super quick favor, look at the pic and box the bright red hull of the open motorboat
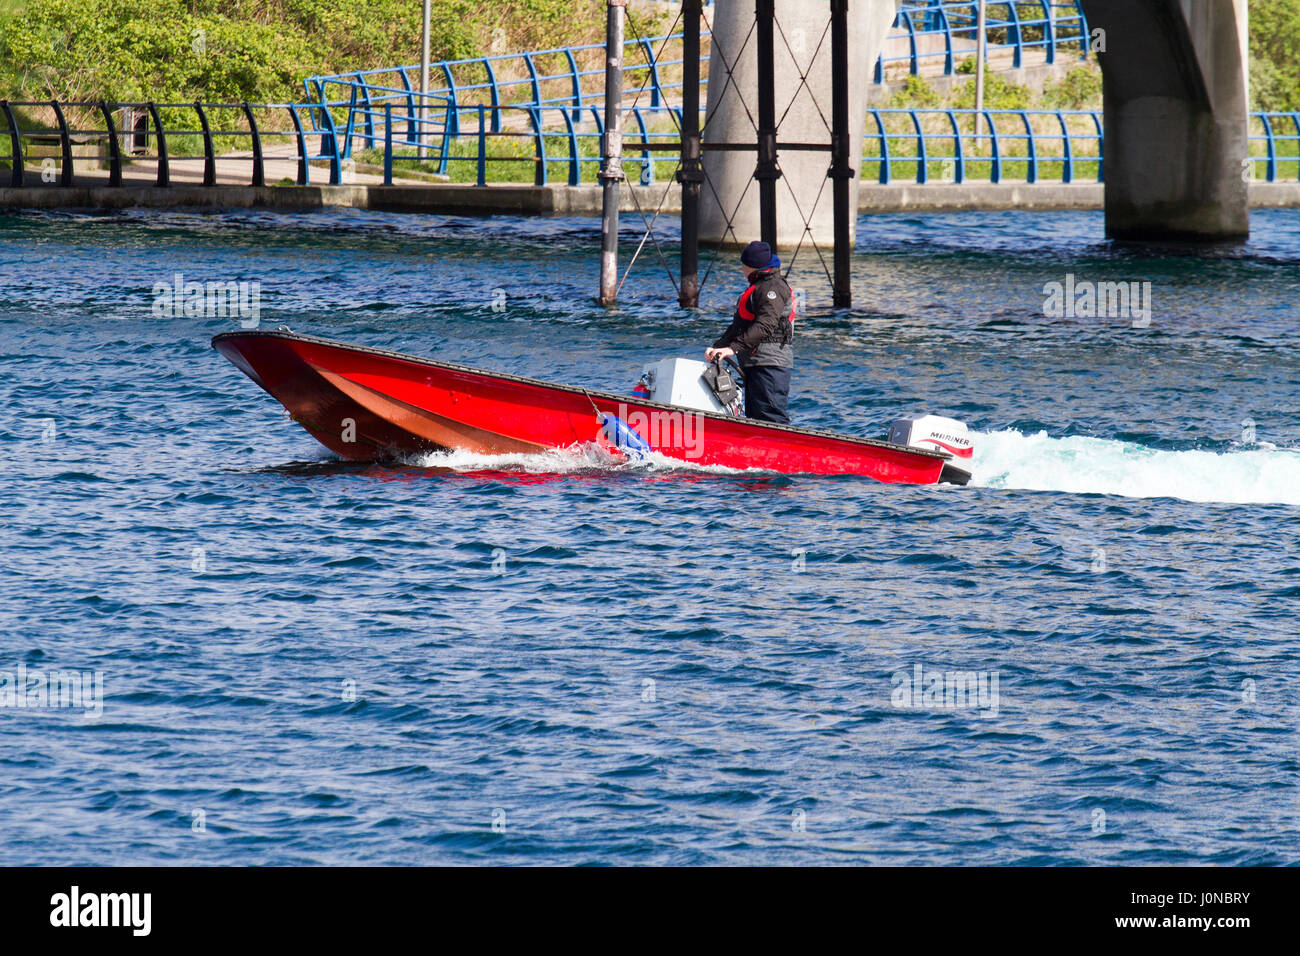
[212,332,967,485]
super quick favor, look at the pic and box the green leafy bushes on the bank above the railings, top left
[0,0,605,101]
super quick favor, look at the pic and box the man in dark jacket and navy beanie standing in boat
[705,242,794,425]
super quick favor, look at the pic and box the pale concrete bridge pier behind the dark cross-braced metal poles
[699,0,898,251]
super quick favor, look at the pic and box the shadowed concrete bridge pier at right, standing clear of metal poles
[1083,0,1251,241]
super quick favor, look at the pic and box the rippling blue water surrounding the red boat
[0,211,1300,865]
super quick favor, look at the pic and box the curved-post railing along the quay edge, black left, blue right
[0,101,1300,186]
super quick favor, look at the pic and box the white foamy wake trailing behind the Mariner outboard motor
[971,429,1300,505]
